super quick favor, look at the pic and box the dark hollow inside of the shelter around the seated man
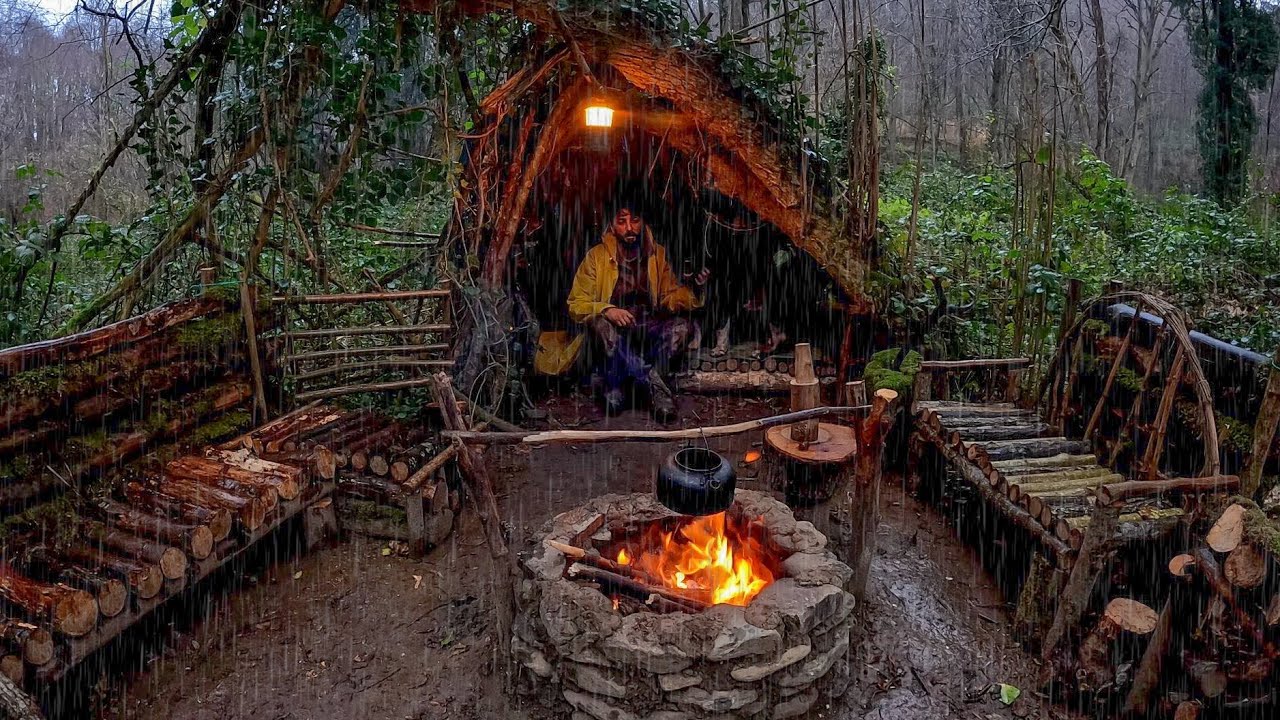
[515,87,842,376]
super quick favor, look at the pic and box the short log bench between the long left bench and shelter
[220,402,461,553]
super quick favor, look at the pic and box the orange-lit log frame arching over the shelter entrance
[414,0,870,303]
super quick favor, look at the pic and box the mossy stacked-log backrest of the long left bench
[0,296,252,509]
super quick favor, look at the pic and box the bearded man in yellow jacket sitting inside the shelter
[538,204,709,421]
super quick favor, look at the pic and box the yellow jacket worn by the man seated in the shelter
[534,227,701,375]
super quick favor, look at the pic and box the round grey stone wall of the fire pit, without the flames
[512,489,854,720]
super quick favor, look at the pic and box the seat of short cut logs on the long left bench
[0,430,325,678]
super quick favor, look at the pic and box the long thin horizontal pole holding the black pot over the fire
[440,405,872,445]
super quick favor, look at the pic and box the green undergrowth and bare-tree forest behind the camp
[0,0,1280,368]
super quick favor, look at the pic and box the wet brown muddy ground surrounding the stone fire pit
[72,397,1066,720]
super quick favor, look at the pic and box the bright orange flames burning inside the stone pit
[617,512,774,605]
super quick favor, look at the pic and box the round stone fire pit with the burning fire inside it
[512,489,854,720]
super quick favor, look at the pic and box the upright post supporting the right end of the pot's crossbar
[845,389,897,605]
